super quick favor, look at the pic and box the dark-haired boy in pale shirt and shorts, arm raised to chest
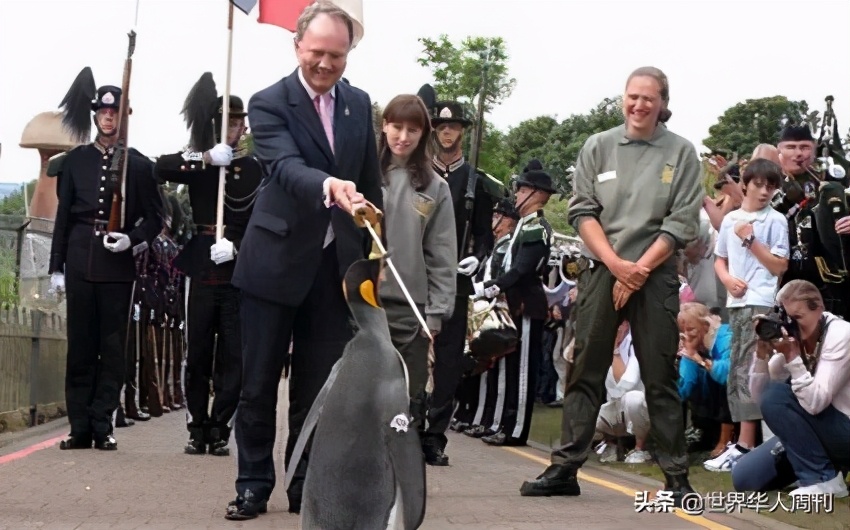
[705,159,789,471]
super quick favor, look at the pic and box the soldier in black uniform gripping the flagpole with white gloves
[156,73,262,456]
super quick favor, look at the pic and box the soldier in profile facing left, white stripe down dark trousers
[474,160,555,446]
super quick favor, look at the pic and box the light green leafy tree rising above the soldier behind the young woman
[418,35,516,180]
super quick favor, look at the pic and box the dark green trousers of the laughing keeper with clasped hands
[552,260,688,475]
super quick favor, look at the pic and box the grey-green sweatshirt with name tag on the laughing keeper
[568,124,705,261]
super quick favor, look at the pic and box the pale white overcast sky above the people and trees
[0,0,850,182]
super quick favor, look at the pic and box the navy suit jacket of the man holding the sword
[233,70,382,307]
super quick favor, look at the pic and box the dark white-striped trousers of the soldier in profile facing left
[500,317,543,443]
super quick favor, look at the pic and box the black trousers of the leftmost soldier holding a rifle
[65,270,133,436]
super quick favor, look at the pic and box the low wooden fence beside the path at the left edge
[0,306,67,432]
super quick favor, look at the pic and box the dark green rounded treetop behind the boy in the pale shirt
[703,96,820,157]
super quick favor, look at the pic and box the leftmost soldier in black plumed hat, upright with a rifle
[49,67,162,450]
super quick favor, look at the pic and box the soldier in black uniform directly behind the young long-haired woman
[419,85,499,466]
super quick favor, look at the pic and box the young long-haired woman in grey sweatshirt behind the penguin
[379,95,457,429]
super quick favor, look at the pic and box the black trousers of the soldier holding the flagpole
[184,281,242,434]
